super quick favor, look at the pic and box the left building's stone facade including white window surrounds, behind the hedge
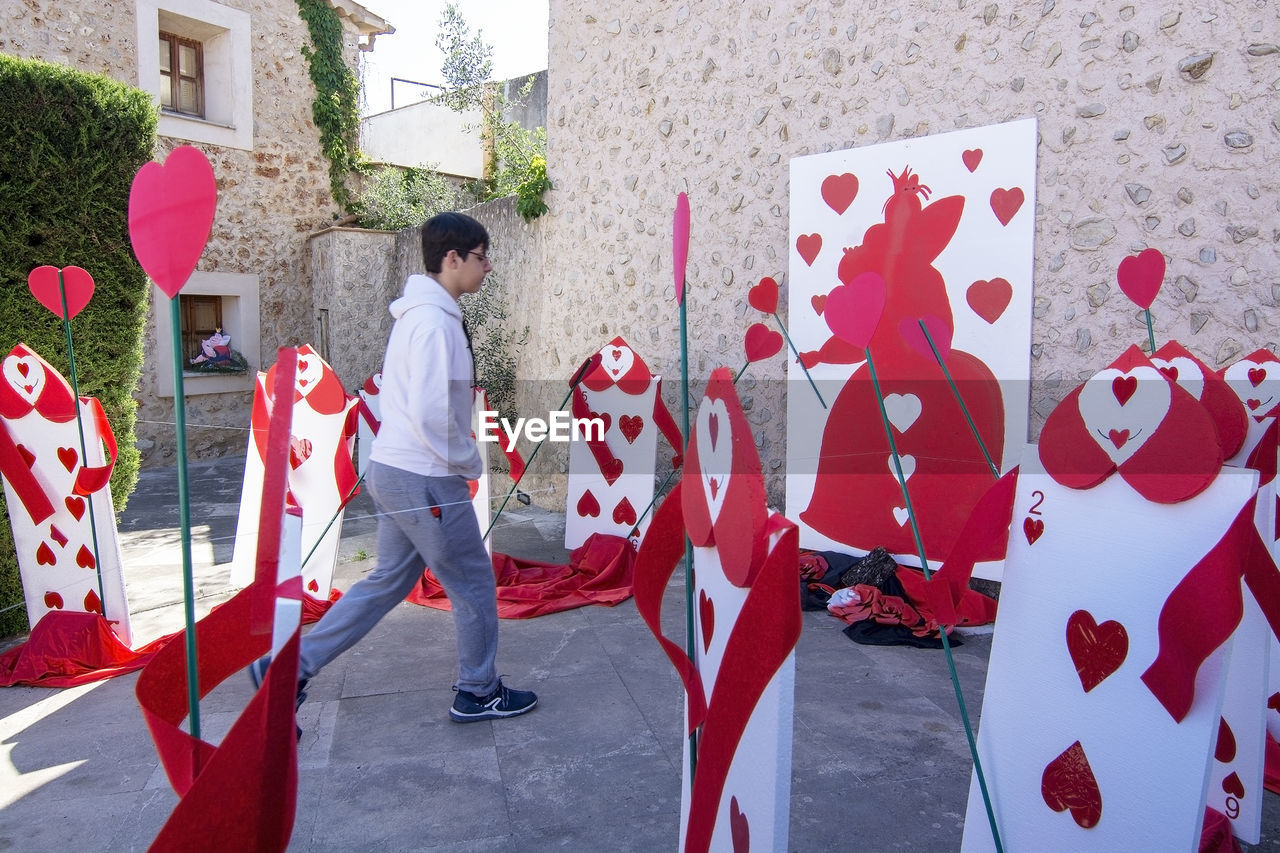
[0,0,390,465]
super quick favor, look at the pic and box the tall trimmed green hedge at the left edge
[0,54,156,637]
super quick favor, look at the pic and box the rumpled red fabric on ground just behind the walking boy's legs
[406,533,636,619]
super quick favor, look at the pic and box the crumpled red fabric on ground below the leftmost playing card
[0,610,174,688]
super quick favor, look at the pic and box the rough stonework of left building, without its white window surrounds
[0,0,357,465]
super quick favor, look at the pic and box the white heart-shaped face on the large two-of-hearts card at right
[1076,365,1172,466]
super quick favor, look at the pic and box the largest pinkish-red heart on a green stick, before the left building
[129,145,218,298]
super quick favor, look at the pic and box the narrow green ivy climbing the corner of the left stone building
[297,0,361,213]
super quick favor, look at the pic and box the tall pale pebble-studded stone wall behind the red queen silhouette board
[521,0,1280,506]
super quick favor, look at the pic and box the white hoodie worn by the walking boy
[369,275,481,480]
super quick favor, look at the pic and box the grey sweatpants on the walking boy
[298,462,498,695]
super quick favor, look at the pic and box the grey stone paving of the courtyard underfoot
[0,460,1280,853]
